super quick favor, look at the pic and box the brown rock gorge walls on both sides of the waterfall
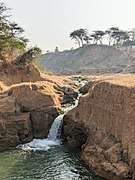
[0,61,135,180]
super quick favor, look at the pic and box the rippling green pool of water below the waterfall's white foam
[0,145,104,180]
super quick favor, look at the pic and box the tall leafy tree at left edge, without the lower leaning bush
[0,3,28,61]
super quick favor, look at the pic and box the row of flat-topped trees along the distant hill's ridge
[70,27,135,48]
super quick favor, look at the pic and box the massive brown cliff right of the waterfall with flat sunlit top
[63,75,135,180]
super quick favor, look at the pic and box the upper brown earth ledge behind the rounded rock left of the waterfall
[0,63,78,103]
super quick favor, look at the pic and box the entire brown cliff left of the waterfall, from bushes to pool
[0,64,77,151]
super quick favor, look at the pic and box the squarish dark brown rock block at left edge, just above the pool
[0,113,33,150]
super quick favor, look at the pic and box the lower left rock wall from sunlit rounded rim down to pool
[0,82,60,150]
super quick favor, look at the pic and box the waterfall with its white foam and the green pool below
[0,92,104,180]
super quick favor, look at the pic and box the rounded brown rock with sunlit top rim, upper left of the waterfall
[10,82,60,111]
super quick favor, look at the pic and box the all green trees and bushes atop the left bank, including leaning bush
[0,3,41,69]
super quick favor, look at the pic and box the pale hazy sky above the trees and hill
[1,0,135,51]
